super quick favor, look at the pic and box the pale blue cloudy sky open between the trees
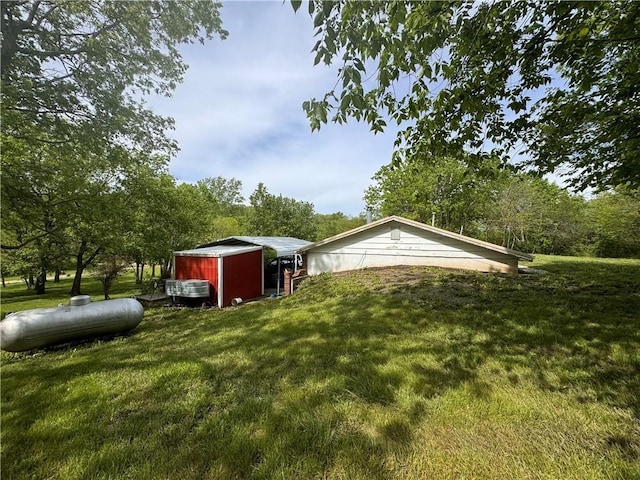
[150,1,396,216]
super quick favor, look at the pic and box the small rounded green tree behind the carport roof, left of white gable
[247,183,316,239]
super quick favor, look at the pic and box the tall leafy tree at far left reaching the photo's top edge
[0,0,226,294]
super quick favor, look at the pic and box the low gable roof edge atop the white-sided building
[298,215,533,261]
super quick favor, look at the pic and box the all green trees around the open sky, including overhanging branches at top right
[0,0,640,294]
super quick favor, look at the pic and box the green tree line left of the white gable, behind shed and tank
[1,167,364,295]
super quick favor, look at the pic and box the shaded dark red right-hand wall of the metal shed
[222,250,263,307]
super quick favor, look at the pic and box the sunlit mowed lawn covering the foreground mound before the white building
[1,256,640,480]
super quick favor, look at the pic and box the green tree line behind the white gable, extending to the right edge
[365,159,640,257]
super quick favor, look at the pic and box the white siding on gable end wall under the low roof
[307,222,518,275]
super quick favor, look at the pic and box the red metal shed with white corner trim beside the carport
[173,246,264,307]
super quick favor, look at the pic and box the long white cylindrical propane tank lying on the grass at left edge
[0,295,144,352]
